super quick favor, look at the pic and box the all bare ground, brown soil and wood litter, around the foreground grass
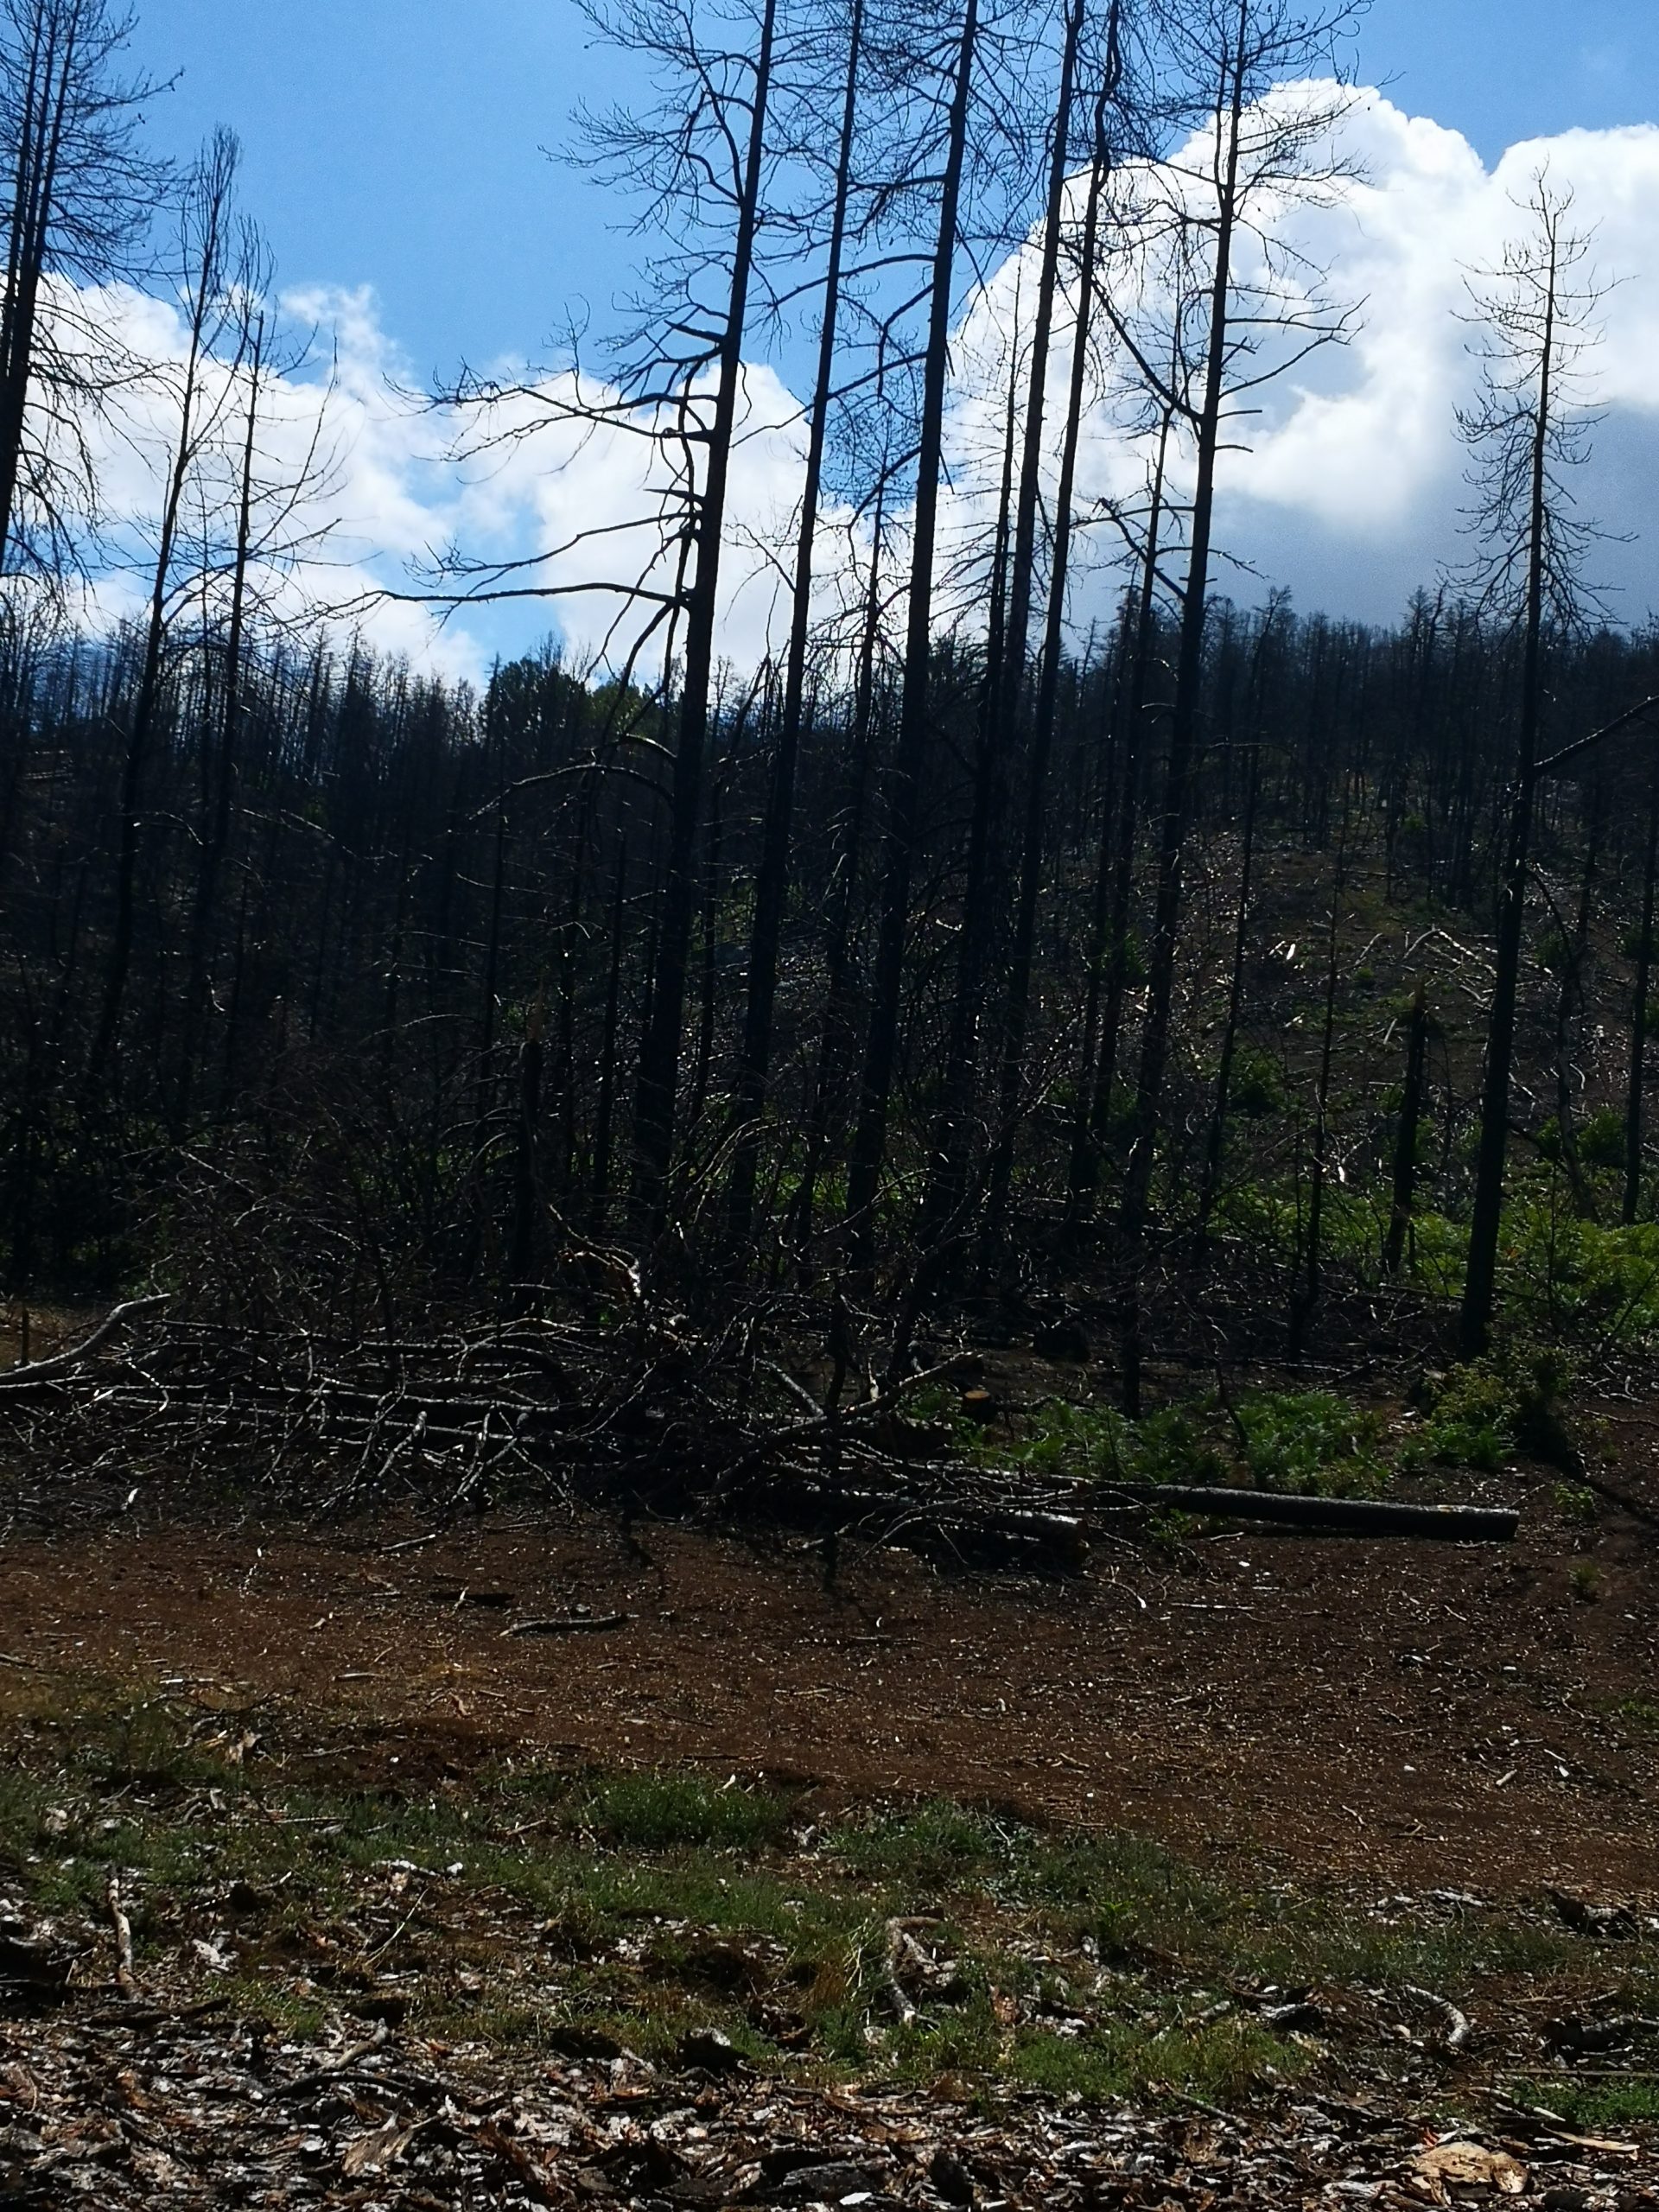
[0,1451,1659,2212]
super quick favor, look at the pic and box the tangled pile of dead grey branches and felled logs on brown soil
[0,1299,1516,1571]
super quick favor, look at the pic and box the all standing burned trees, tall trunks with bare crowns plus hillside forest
[0,0,1659,1421]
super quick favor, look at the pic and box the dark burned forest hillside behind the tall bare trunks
[4,608,1659,1356]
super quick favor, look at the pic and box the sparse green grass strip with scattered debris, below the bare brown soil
[0,1699,1659,2124]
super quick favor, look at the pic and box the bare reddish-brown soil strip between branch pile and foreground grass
[0,1440,1659,1896]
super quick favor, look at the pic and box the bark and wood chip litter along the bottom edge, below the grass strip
[0,2008,1659,2212]
